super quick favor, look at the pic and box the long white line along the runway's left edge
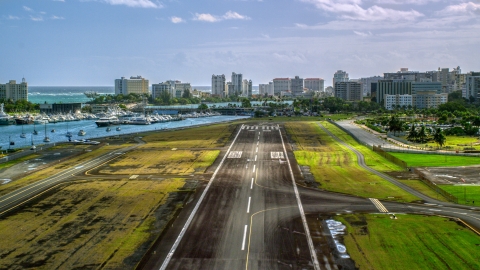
[159,125,244,270]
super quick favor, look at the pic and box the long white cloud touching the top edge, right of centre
[301,0,424,21]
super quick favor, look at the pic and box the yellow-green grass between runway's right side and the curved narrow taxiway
[285,122,418,202]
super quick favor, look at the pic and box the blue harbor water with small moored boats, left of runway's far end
[0,115,248,151]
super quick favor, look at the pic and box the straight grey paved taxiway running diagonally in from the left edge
[0,138,143,215]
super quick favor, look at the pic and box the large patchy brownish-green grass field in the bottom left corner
[0,179,185,269]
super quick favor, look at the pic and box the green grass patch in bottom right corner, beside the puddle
[336,215,480,270]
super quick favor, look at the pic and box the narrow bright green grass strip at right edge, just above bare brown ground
[390,153,480,167]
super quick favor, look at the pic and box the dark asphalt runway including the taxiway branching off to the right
[143,124,480,269]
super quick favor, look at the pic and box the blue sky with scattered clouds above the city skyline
[0,0,480,86]
